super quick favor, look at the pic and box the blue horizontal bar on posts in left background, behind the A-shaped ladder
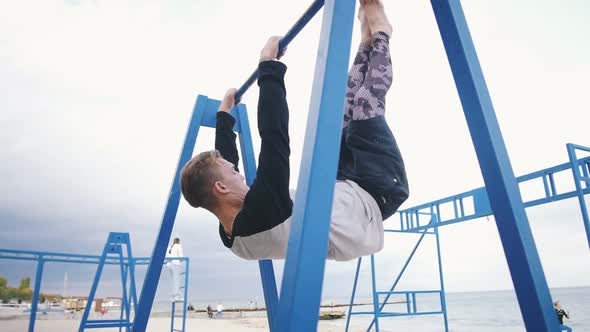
[0,240,189,332]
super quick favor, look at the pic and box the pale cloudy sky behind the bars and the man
[0,0,590,308]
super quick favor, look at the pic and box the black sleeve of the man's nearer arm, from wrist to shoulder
[231,61,293,239]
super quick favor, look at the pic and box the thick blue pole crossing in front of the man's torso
[278,0,355,332]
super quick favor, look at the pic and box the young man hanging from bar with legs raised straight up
[181,0,409,260]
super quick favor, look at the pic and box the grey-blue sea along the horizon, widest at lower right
[154,287,590,332]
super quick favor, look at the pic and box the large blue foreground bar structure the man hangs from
[133,0,564,332]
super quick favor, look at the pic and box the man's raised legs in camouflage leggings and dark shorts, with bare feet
[339,0,409,220]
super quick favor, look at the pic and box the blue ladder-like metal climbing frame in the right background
[346,144,590,331]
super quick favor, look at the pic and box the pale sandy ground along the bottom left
[0,317,350,332]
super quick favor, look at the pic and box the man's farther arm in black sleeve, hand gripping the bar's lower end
[215,89,240,171]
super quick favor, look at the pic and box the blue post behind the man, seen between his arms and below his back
[236,104,279,331]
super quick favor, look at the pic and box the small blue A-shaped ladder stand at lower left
[78,232,137,332]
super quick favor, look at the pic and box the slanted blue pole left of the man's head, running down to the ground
[133,96,207,332]
